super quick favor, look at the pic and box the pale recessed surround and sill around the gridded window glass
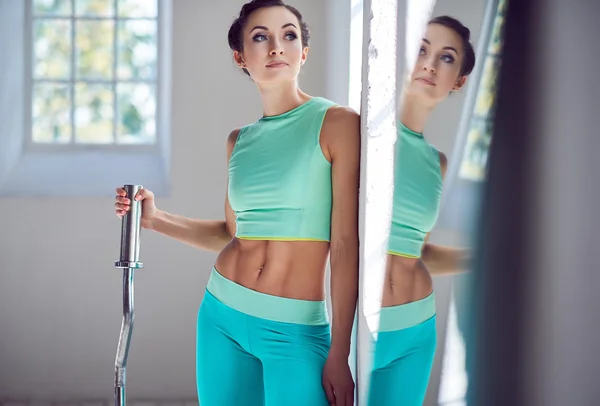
[0,0,172,197]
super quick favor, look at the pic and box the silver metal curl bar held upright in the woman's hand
[115,185,144,406]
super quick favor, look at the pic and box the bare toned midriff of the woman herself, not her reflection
[215,238,329,300]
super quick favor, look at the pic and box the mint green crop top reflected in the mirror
[388,122,443,258]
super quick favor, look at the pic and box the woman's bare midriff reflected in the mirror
[381,255,433,307]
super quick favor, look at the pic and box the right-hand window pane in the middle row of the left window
[117,20,157,80]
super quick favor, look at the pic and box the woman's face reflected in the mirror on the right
[408,24,466,104]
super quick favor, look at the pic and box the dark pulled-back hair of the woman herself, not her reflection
[227,0,310,75]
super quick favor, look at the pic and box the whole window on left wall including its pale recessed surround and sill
[0,0,172,197]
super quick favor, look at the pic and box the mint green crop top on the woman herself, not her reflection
[228,97,335,241]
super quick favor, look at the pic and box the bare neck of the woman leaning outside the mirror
[258,80,310,117]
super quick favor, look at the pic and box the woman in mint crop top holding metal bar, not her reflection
[116,0,360,406]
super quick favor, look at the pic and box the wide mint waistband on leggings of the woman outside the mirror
[206,267,329,326]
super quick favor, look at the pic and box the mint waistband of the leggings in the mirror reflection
[379,292,435,332]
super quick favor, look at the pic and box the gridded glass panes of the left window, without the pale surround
[30,0,158,145]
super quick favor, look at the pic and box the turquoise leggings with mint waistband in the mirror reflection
[368,293,436,406]
